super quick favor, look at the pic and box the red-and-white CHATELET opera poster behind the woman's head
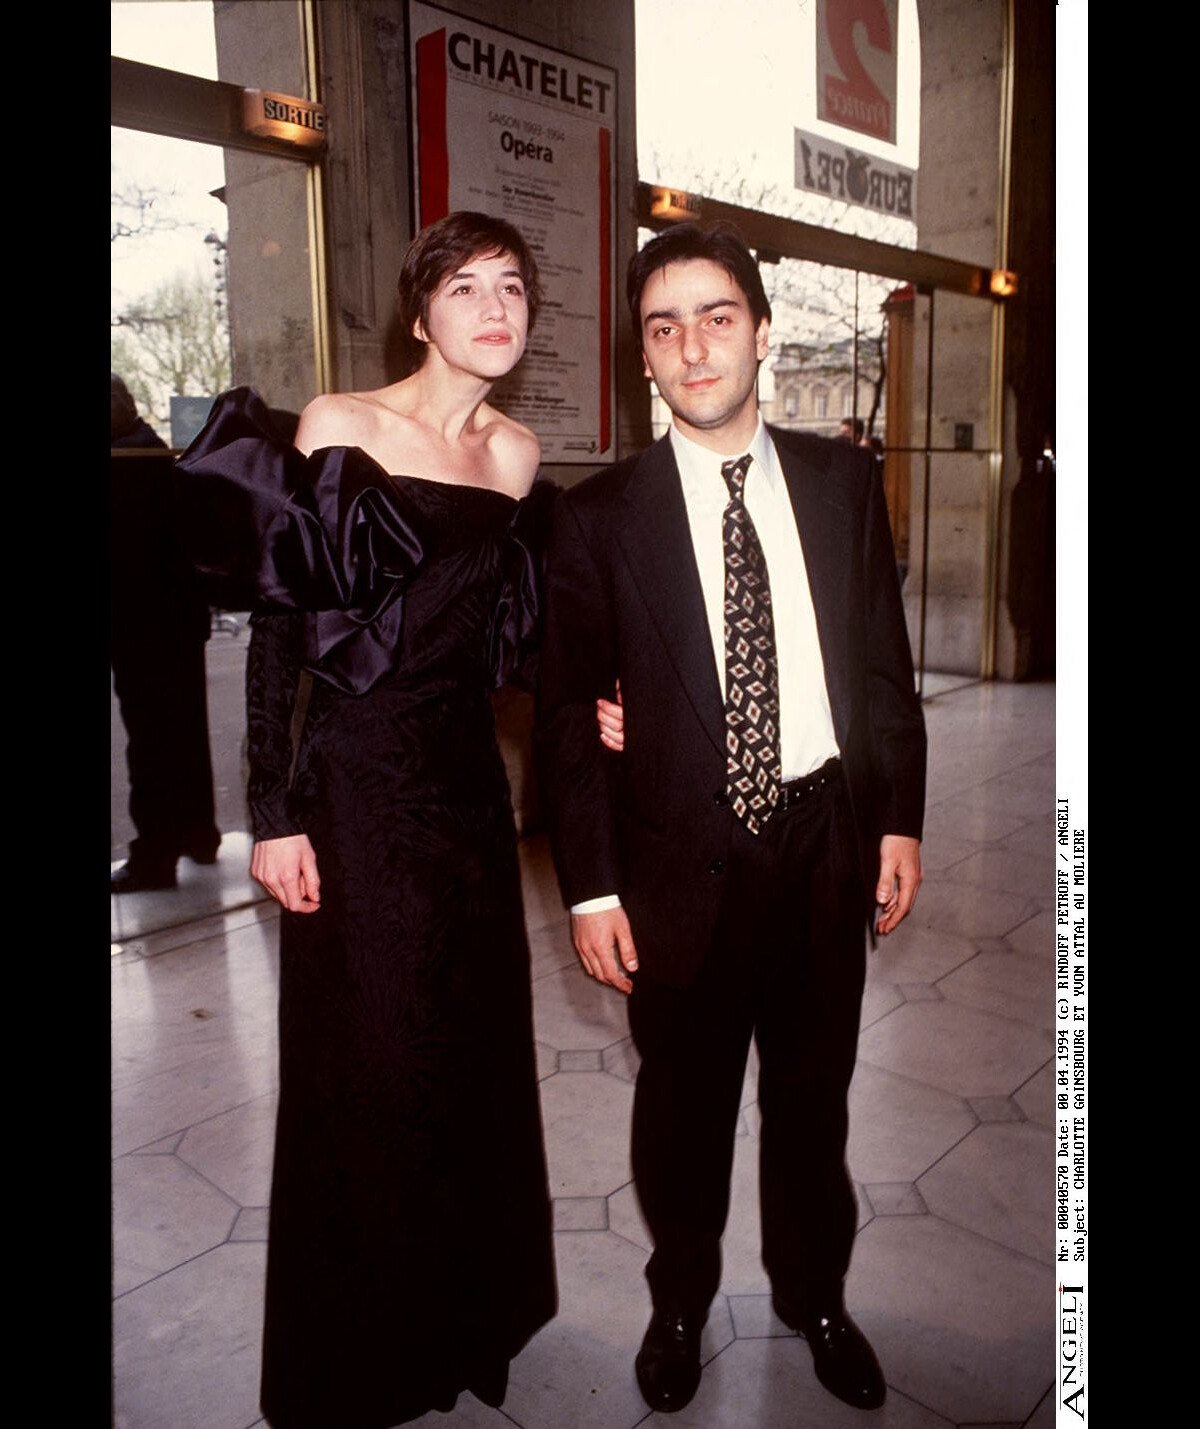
[409,0,617,464]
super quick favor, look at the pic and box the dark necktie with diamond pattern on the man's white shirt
[721,454,783,833]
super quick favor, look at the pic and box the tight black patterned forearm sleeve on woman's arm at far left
[246,612,304,839]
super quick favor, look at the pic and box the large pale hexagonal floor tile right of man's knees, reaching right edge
[859,1002,1053,1096]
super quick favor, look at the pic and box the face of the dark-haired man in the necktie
[641,259,770,446]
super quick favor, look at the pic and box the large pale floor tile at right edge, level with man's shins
[917,1122,1054,1265]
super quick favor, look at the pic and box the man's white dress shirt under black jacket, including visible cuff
[571,414,839,913]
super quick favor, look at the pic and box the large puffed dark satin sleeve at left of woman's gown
[176,387,433,693]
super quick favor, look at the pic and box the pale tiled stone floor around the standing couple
[111,684,1054,1429]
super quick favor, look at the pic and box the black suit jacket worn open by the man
[537,427,926,985]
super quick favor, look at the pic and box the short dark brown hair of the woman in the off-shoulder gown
[396,209,541,377]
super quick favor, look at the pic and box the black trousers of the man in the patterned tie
[629,776,866,1315]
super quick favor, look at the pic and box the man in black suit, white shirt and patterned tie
[539,224,926,1412]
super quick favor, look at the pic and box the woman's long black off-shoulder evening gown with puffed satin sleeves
[180,389,556,1429]
